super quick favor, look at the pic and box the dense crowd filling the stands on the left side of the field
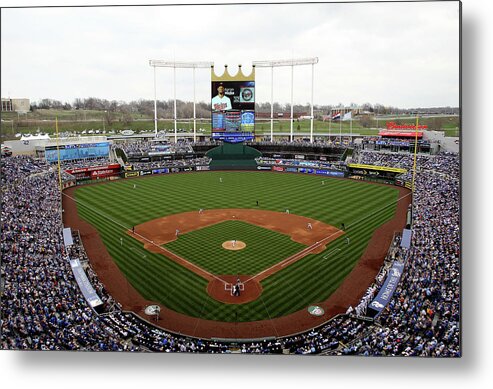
[0,157,135,351]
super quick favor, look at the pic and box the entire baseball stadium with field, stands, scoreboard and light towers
[1,58,460,357]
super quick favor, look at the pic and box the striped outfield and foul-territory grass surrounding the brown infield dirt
[75,172,399,321]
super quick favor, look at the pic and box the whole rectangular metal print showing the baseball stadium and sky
[0,1,462,360]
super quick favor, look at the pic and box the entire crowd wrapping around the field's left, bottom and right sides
[0,152,460,356]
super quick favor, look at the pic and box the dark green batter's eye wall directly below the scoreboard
[205,143,262,170]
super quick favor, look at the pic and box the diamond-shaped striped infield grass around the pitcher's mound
[165,221,306,275]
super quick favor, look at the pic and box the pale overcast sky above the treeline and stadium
[0,1,459,108]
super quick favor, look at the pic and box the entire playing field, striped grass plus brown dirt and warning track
[64,171,410,338]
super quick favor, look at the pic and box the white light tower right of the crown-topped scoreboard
[253,57,318,143]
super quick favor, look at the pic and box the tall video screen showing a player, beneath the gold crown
[211,81,255,142]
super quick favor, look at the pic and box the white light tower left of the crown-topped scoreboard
[149,59,214,143]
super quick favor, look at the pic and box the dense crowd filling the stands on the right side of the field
[330,153,460,357]
